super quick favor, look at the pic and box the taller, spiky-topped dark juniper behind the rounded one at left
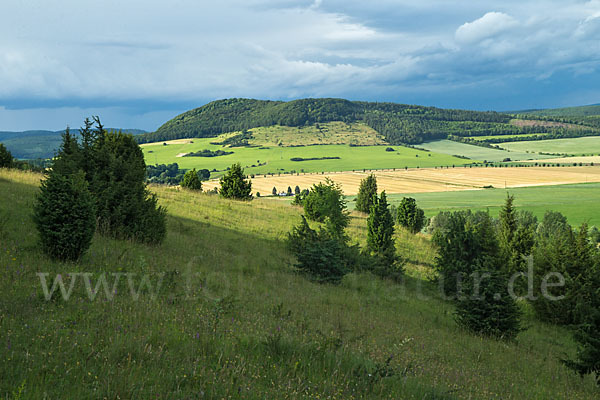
[52,117,166,244]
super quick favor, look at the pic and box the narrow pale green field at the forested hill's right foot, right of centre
[418,140,548,162]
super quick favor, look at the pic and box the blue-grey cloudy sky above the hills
[0,0,600,131]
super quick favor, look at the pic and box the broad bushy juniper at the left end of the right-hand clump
[432,210,503,296]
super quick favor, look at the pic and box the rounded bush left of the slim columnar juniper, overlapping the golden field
[302,178,350,236]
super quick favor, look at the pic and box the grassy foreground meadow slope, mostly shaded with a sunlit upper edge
[0,170,598,399]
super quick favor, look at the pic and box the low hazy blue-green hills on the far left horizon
[0,128,146,160]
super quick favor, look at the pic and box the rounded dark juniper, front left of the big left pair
[33,171,96,261]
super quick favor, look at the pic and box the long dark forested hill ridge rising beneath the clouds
[137,98,600,144]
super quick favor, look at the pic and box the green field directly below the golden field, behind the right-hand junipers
[380,183,600,227]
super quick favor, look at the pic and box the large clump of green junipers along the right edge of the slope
[430,196,600,382]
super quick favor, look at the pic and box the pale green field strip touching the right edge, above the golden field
[499,136,600,155]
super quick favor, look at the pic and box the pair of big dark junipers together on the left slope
[34,117,166,260]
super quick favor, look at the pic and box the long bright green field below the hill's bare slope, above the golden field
[142,138,472,176]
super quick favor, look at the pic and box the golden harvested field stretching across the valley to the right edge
[203,166,600,196]
